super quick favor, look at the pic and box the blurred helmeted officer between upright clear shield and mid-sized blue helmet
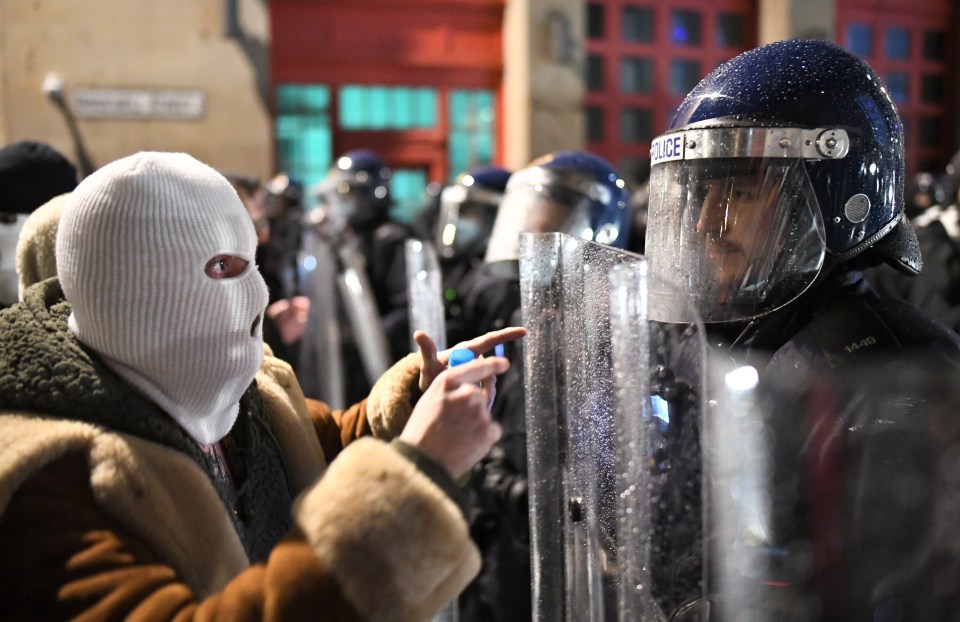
[431,166,510,343]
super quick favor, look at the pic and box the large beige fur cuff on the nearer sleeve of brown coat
[294,438,480,622]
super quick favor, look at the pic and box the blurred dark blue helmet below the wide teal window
[314,149,393,229]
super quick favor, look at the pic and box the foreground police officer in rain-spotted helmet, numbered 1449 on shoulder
[646,40,960,620]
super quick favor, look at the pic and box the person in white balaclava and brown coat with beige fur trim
[0,153,523,620]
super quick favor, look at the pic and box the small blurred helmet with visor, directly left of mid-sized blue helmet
[436,166,510,260]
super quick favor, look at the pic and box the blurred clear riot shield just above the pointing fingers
[404,240,447,352]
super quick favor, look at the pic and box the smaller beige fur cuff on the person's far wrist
[367,352,420,440]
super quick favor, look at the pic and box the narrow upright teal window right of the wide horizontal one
[447,90,495,180]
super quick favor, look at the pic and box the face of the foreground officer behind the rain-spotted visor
[697,176,774,304]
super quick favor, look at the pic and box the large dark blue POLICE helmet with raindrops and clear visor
[646,40,921,322]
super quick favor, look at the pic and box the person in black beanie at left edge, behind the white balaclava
[0,140,77,309]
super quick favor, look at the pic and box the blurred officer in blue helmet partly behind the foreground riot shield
[456,151,631,622]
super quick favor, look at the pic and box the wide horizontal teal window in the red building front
[337,85,437,130]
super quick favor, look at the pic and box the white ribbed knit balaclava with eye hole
[56,152,267,444]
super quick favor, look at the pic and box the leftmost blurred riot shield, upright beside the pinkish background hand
[297,229,346,408]
